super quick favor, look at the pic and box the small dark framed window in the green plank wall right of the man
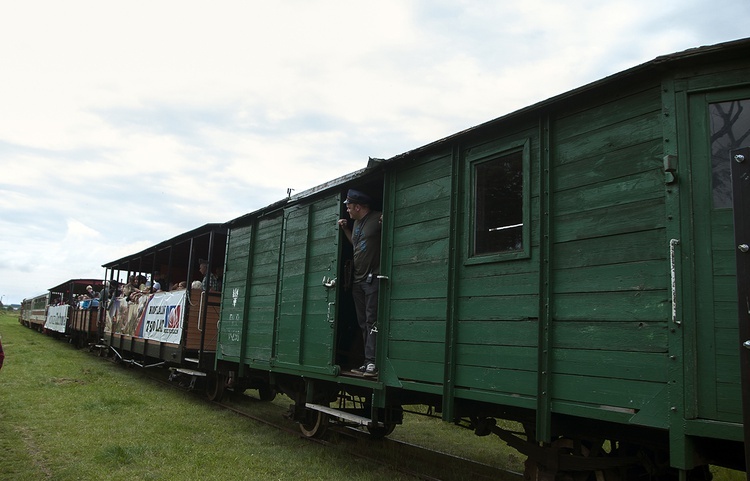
[473,151,524,255]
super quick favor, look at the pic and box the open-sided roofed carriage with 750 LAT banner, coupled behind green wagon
[102,224,226,382]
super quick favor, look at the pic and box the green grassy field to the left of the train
[0,311,428,481]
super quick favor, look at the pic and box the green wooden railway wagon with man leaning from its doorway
[217,39,750,479]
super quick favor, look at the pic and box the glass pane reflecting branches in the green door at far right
[709,99,750,209]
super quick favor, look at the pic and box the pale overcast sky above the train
[0,0,750,304]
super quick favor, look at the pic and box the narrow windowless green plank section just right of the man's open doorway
[388,153,452,384]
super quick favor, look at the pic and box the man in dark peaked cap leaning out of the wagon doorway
[338,189,383,377]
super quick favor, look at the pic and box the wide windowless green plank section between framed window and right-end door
[550,84,670,413]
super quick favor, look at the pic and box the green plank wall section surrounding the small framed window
[455,124,540,406]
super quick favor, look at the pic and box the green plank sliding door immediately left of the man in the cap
[273,196,339,374]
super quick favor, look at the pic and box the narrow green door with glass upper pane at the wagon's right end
[685,91,750,426]
